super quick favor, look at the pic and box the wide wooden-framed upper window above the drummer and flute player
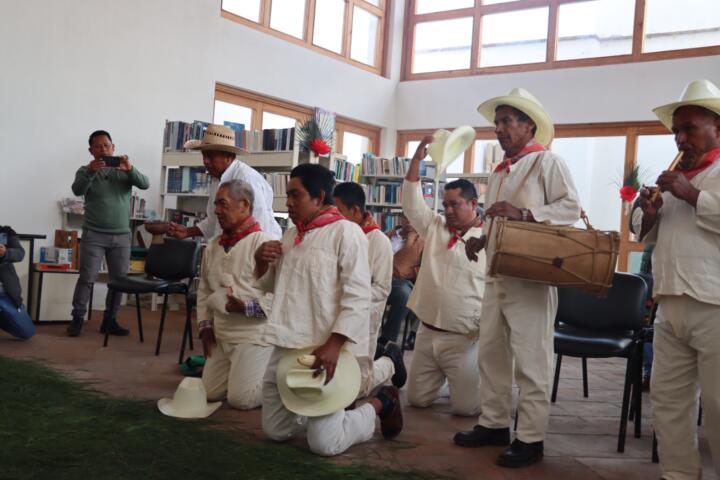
[402,0,720,80]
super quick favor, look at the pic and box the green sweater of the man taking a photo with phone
[72,166,150,234]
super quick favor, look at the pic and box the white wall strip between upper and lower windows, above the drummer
[395,56,720,130]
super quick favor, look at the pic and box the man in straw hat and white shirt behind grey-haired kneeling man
[169,124,282,240]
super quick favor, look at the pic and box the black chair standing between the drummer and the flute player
[551,273,647,453]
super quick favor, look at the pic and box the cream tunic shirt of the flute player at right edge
[633,161,720,305]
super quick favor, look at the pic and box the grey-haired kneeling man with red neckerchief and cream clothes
[197,180,272,410]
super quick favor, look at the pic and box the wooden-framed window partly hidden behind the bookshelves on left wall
[213,84,381,163]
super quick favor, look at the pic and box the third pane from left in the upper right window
[556,0,635,60]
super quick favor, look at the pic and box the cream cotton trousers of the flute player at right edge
[650,295,720,480]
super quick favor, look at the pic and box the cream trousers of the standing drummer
[478,278,557,443]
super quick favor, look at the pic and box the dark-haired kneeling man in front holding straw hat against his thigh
[255,164,402,456]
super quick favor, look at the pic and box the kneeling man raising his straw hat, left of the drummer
[402,142,485,415]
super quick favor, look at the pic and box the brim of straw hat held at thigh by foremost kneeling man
[276,347,361,417]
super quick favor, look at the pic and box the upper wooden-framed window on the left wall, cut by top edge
[221,0,391,75]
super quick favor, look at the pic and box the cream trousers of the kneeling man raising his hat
[408,324,480,416]
